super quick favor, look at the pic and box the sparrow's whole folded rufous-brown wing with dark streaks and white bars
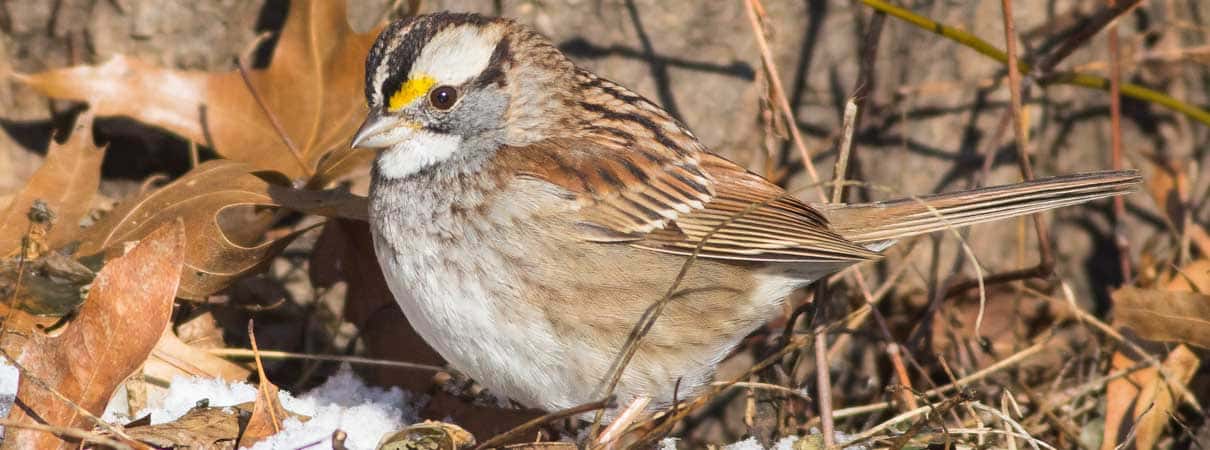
[496,135,880,263]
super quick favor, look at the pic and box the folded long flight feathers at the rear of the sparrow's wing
[632,152,881,263]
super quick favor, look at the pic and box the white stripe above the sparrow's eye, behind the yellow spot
[408,24,503,86]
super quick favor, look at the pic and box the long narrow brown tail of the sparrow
[824,171,1141,247]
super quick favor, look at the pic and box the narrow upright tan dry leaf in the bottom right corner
[1134,345,1199,450]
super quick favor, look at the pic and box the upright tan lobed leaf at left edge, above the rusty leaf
[0,111,105,256]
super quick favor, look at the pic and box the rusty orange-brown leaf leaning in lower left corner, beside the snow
[4,221,185,449]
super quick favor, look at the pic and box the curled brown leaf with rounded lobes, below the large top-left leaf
[79,160,298,299]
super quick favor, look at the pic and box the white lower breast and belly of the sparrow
[374,230,583,409]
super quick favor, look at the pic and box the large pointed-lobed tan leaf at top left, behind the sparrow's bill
[16,0,380,179]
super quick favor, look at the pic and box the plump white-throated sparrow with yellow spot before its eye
[351,12,1140,410]
